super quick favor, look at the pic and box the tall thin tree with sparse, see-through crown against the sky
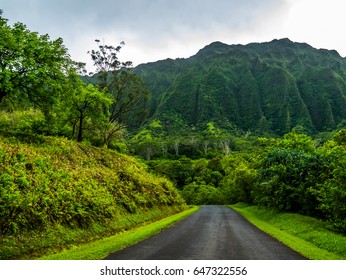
[89,40,149,136]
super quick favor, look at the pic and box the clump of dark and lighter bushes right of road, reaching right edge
[252,130,346,233]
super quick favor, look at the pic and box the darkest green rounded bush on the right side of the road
[254,148,331,216]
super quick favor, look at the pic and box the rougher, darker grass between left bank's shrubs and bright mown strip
[0,206,187,260]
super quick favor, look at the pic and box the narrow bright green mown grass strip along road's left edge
[39,206,199,260]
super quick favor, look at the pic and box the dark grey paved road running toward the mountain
[106,206,304,260]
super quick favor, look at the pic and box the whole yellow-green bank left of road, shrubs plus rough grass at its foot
[0,137,185,259]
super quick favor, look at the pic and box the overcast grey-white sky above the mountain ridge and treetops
[0,0,346,70]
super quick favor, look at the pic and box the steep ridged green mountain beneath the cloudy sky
[134,38,346,135]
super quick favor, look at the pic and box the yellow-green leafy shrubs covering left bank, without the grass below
[0,135,187,235]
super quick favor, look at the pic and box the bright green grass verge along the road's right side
[230,203,346,260]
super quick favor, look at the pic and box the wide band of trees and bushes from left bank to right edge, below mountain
[134,130,346,233]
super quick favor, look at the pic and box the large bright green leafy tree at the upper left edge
[0,13,79,111]
